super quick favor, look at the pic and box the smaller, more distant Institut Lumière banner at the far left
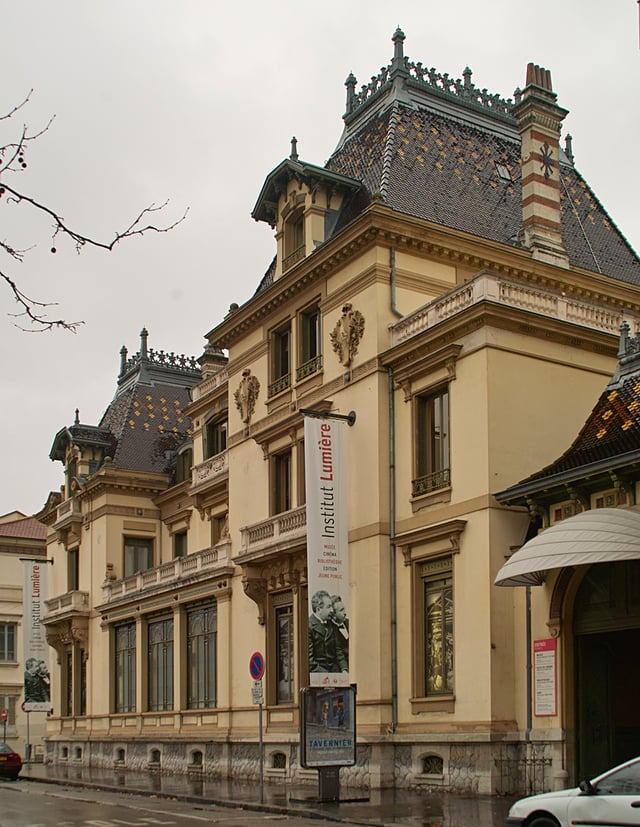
[22,560,51,712]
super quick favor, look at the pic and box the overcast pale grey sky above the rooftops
[0,0,640,515]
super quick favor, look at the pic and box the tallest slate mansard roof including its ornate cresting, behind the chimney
[254,30,640,287]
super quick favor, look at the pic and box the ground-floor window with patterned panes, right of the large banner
[423,564,453,696]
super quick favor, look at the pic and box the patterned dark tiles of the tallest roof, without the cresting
[327,102,640,284]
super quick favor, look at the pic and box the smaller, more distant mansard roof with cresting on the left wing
[50,330,201,473]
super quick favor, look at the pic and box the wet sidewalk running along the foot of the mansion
[20,763,513,827]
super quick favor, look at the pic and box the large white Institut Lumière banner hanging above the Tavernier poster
[304,416,349,686]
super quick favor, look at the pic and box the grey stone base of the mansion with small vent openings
[45,735,566,795]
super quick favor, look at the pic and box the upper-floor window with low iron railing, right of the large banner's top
[412,390,451,497]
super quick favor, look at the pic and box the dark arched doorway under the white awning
[573,560,640,778]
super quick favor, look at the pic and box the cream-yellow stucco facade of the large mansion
[36,32,640,793]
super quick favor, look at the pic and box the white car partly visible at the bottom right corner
[505,758,640,827]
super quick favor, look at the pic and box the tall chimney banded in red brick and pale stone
[513,63,569,267]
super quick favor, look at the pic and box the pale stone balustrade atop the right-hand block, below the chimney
[391,272,637,345]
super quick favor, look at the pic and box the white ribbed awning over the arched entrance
[495,508,640,586]
